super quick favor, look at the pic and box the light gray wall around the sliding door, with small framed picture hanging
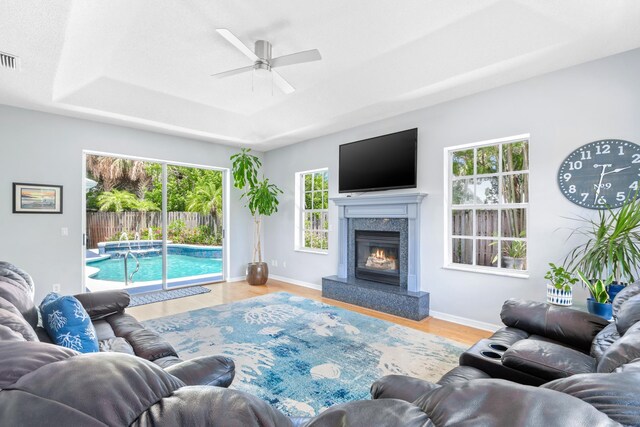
[0,106,252,302]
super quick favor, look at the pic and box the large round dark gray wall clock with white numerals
[558,139,640,209]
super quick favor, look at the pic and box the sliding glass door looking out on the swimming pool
[84,153,225,293]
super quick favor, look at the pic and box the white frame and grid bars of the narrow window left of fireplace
[294,167,331,255]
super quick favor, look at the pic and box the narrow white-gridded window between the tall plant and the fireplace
[296,169,329,252]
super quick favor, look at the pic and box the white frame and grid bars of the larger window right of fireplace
[443,134,532,278]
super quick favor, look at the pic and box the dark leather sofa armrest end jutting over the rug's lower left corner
[165,356,235,387]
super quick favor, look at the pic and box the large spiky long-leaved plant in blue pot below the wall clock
[565,193,640,299]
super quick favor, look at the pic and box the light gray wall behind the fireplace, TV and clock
[265,50,640,324]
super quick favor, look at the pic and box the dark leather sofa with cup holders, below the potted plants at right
[460,284,640,385]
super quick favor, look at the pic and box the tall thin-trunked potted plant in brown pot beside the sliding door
[231,148,282,285]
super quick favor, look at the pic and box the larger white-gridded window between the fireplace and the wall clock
[445,135,529,272]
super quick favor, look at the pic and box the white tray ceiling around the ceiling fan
[0,0,640,151]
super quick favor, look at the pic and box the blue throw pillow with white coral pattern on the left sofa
[40,292,100,353]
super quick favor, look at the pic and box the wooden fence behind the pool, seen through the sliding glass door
[87,212,215,249]
